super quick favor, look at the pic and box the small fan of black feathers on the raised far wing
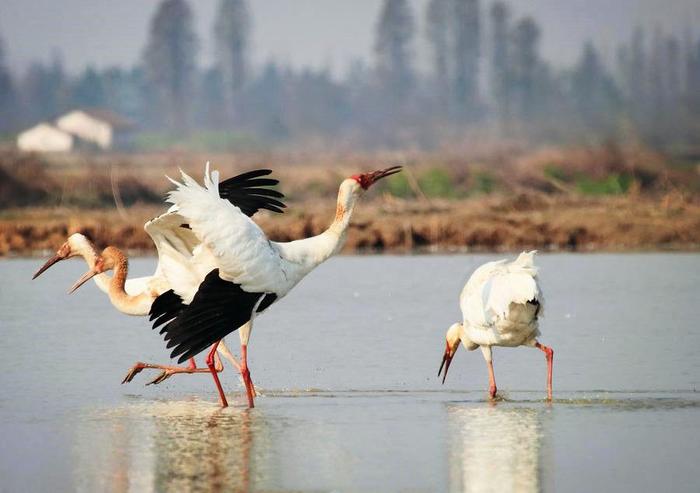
[219,169,287,216]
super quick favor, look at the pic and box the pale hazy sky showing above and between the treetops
[0,0,700,76]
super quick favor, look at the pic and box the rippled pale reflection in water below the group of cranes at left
[74,401,269,491]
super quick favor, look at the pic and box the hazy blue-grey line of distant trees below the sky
[0,0,700,147]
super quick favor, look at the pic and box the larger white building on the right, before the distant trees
[56,109,134,149]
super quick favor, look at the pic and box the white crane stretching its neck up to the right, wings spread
[151,164,401,407]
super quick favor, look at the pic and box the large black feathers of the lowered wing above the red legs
[157,269,277,363]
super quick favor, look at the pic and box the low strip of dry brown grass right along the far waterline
[0,194,700,255]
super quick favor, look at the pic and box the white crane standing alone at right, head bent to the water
[438,250,554,400]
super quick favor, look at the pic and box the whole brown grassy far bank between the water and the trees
[0,147,700,255]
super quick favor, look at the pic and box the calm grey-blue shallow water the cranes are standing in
[0,254,700,492]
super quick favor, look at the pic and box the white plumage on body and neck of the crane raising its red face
[164,164,348,301]
